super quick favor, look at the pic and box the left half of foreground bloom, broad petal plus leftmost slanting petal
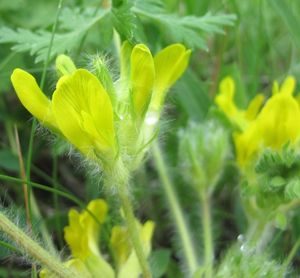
[11,69,116,162]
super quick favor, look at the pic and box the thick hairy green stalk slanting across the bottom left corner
[0,212,78,278]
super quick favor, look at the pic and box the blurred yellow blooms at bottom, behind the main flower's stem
[40,199,154,278]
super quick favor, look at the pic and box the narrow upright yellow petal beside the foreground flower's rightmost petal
[131,44,155,117]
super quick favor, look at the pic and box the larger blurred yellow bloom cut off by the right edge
[219,76,300,167]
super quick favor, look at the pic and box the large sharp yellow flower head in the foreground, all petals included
[11,43,191,169]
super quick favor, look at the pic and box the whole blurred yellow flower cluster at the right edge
[215,76,300,167]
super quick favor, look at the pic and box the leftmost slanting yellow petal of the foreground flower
[11,69,56,128]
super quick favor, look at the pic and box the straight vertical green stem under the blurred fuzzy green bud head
[200,189,214,278]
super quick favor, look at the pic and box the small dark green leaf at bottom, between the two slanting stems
[150,249,171,278]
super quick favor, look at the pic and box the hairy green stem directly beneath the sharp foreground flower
[111,163,152,278]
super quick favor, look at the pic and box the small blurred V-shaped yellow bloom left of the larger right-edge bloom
[215,76,264,130]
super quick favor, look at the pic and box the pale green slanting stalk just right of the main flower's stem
[152,142,198,274]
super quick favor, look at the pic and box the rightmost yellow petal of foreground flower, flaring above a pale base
[151,44,191,110]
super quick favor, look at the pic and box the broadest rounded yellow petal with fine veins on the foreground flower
[53,69,115,153]
